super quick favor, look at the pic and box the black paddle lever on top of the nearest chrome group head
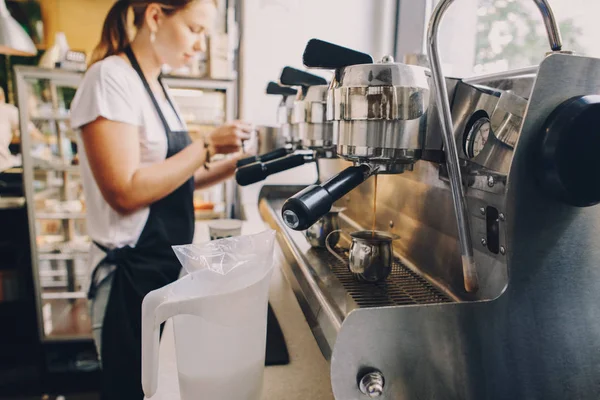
[302,39,373,69]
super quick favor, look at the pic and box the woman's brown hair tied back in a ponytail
[90,0,202,65]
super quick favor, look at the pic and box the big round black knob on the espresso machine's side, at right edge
[536,95,600,207]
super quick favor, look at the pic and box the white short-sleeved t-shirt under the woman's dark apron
[71,56,187,248]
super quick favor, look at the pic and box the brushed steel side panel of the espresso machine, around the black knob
[331,55,600,400]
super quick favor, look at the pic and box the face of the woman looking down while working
[154,0,217,68]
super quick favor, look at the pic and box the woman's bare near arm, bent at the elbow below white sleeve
[81,118,206,214]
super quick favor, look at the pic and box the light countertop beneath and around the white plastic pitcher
[145,206,333,400]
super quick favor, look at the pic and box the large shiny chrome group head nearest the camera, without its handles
[327,62,430,168]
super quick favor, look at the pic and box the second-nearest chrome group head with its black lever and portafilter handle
[236,67,336,186]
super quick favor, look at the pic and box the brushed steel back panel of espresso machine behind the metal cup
[319,160,508,300]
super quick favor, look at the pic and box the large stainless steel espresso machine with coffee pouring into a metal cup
[254,0,600,400]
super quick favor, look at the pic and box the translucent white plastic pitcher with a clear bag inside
[142,231,275,400]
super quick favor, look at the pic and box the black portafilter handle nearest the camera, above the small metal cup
[281,164,371,231]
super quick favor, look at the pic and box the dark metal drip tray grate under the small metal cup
[314,249,452,308]
